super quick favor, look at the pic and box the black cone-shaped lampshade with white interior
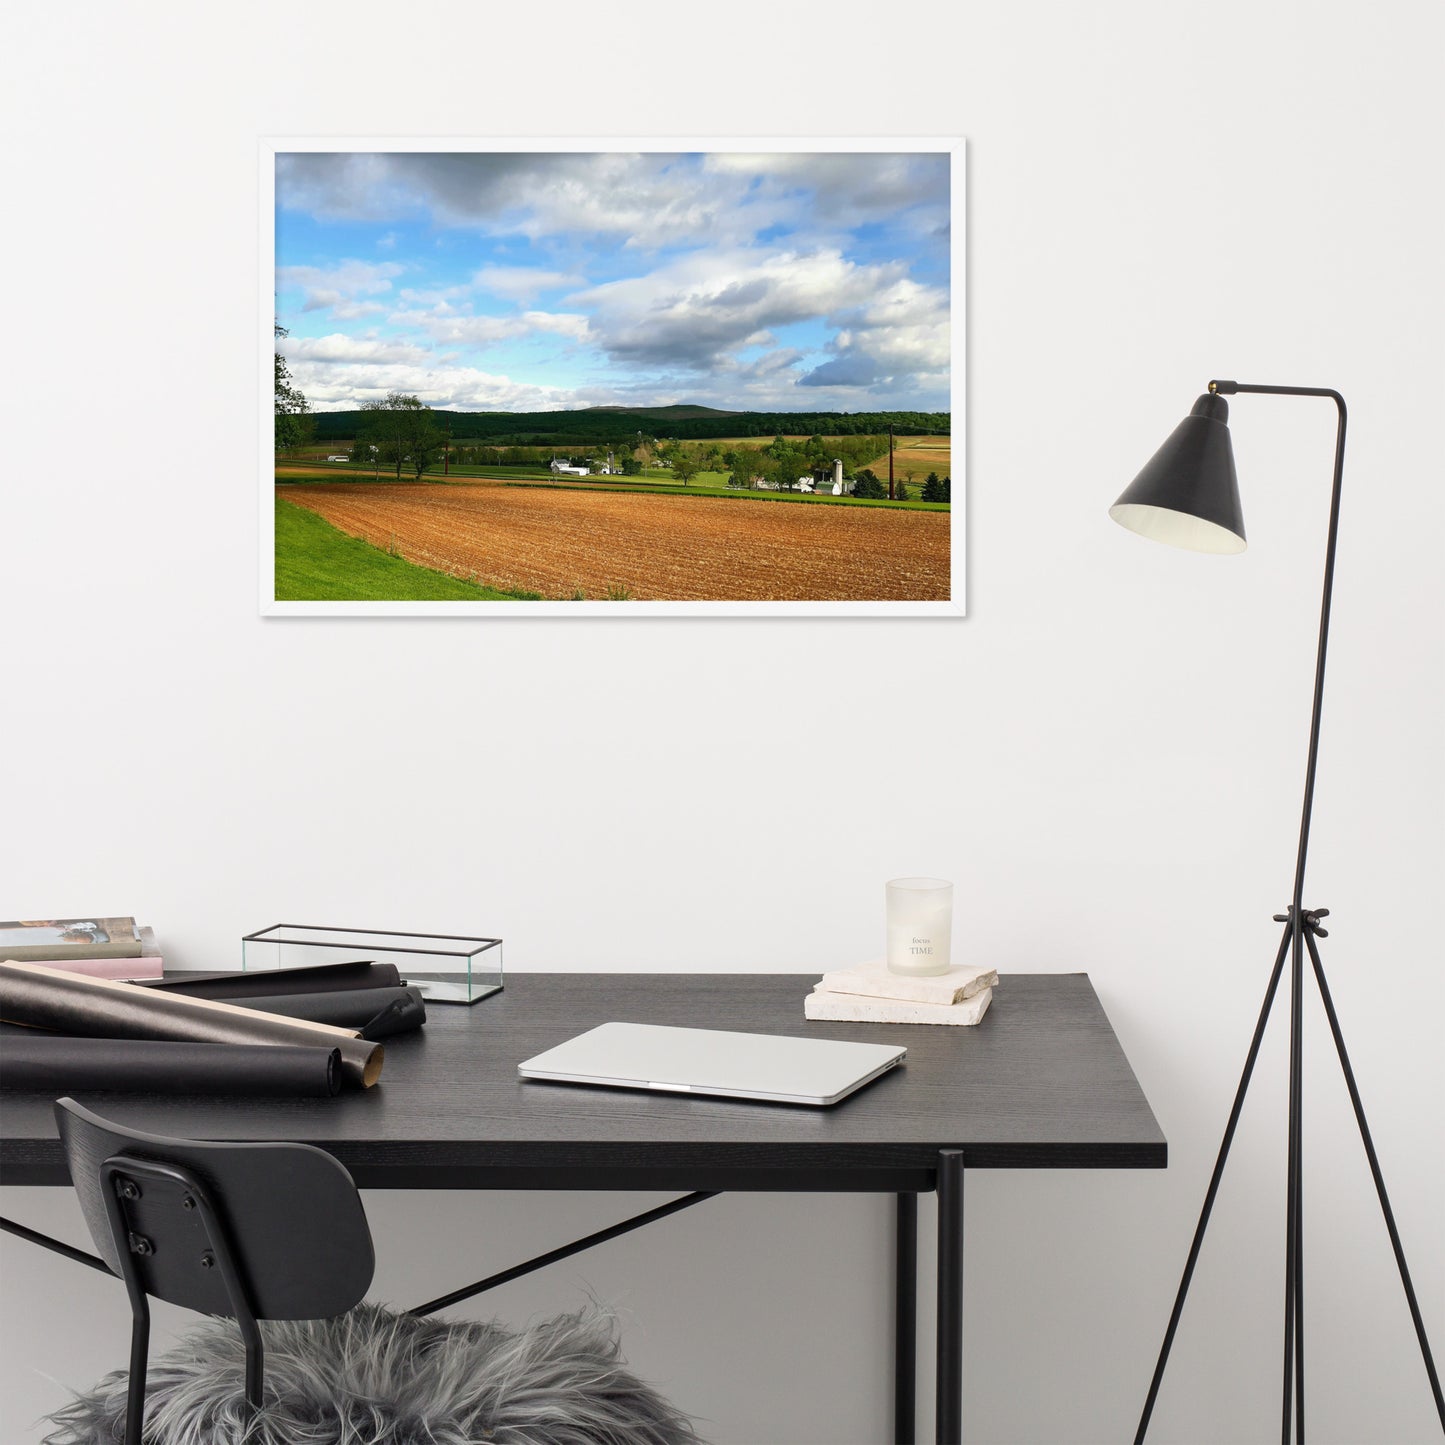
[1108,392,1246,552]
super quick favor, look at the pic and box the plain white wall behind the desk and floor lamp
[0,0,1445,1445]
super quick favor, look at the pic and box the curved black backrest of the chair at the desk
[55,1098,376,1319]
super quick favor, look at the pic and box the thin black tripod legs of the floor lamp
[1134,905,1445,1445]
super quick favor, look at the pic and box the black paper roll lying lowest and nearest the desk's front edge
[0,1029,341,1098]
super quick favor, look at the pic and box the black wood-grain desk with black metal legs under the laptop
[0,974,1166,1445]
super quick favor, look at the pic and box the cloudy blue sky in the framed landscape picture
[275,152,949,412]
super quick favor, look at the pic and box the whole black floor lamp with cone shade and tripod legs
[1108,381,1445,1445]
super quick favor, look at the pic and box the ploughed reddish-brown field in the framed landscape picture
[280,481,949,601]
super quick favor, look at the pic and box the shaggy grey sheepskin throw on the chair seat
[45,1305,699,1445]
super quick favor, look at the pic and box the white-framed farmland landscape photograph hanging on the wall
[262,140,964,616]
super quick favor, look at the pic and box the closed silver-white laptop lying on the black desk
[517,1023,907,1104]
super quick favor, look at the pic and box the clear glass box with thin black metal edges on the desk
[241,923,501,1003]
